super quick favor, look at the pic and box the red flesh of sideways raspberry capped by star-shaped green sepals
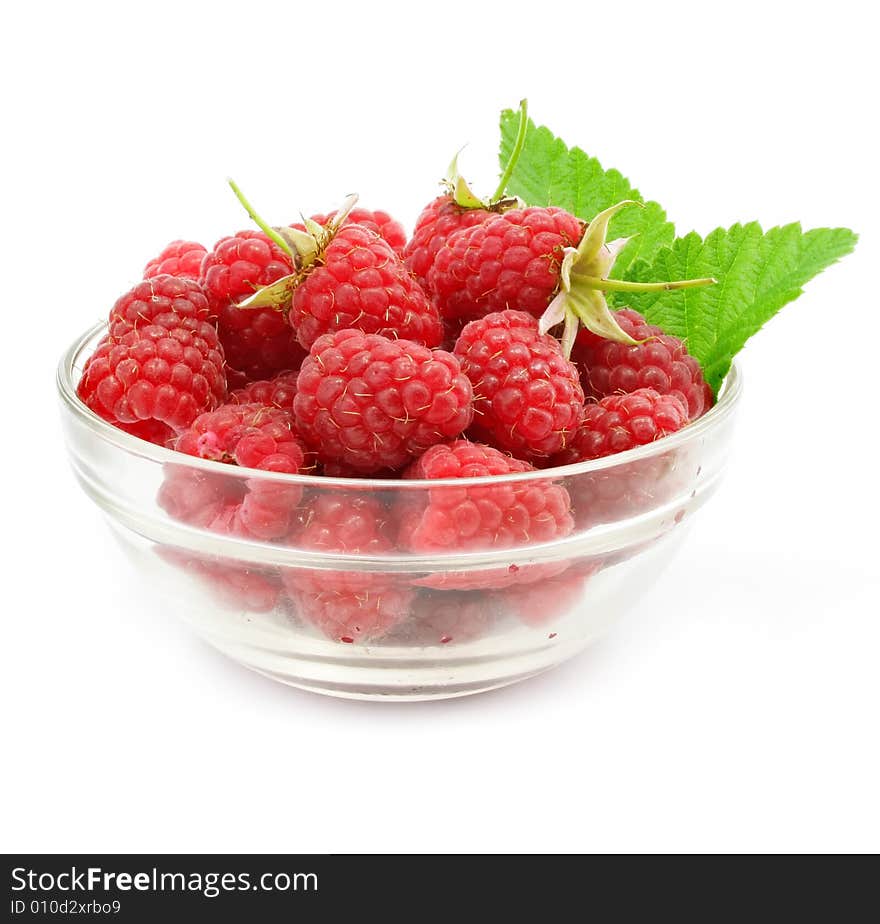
[428,207,584,320]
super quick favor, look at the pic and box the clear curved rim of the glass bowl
[57,321,742,491]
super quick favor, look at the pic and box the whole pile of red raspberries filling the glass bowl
[78,194,712,642]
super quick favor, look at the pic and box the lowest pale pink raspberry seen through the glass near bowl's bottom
[293,587,413,642]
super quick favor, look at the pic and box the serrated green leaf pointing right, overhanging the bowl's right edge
[618,222,858,391]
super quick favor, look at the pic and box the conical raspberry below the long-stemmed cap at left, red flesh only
[290,225,443,349]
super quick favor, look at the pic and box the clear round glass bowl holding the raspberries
[58,325,740,700]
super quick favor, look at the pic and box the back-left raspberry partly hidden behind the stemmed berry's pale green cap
[201,231,304,386]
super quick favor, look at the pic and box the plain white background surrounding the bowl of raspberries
[0,0,880,851]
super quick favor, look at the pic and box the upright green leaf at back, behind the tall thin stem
[499,109,675,279]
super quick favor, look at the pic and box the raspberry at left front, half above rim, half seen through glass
[168,404,304,540]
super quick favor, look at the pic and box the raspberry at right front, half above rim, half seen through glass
[552,388,687,526]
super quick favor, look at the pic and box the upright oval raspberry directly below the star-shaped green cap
[455,311,584,458]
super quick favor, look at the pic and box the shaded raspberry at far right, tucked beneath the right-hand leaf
[572,308,712,420]
